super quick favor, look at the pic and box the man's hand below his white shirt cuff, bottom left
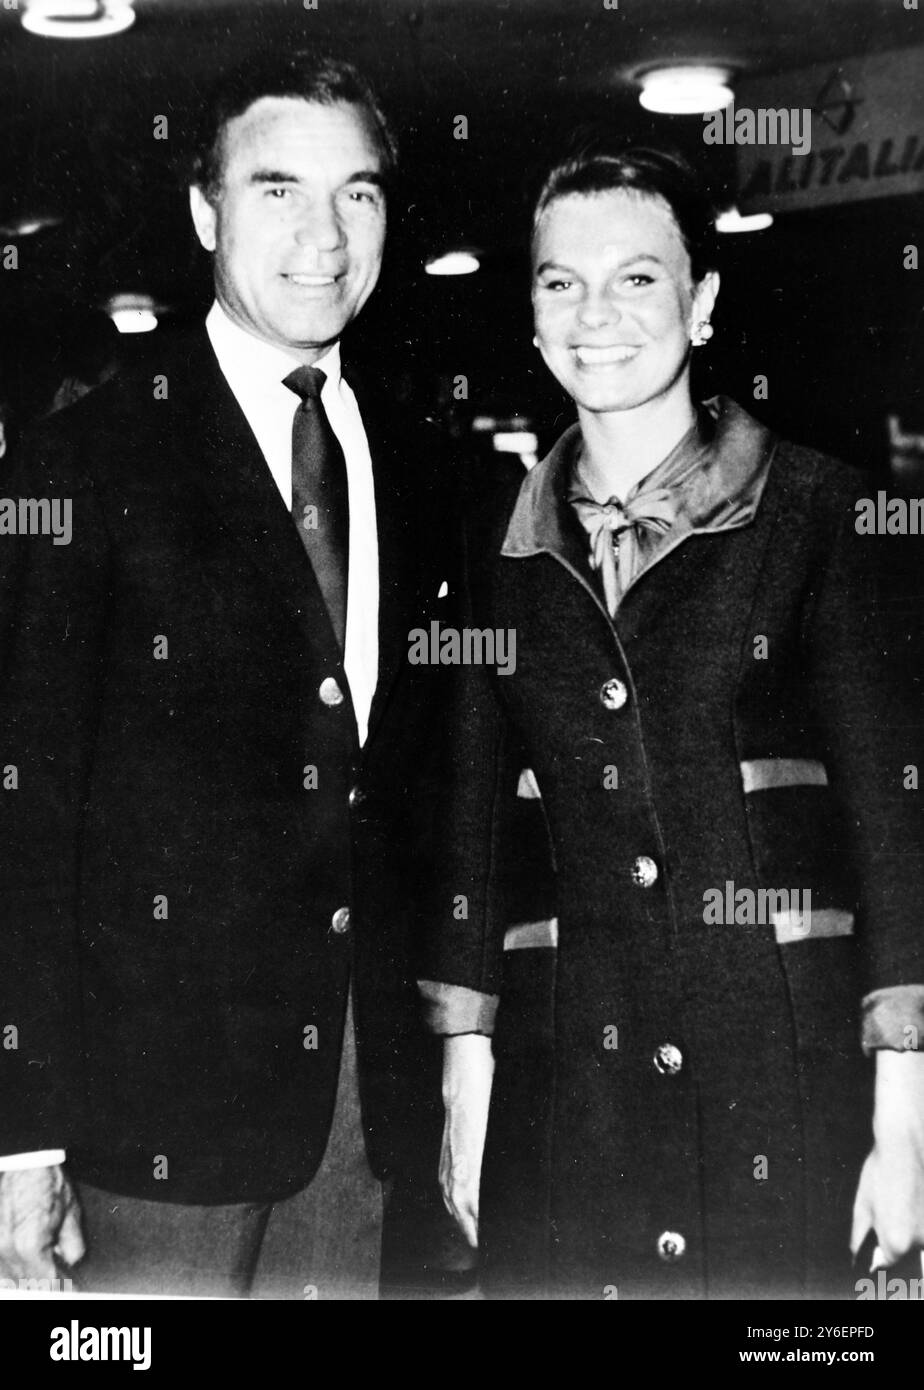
[0,1165,85,1279]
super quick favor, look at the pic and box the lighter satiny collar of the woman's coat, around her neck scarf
[500,396,777,598]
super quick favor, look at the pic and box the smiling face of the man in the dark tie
[190,97,385,363]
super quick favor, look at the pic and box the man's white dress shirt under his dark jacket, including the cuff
[0,302,378,1172]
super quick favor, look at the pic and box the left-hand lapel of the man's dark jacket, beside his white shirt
[171,331,346,688]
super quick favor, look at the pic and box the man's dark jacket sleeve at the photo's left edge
[0,431,108,1154]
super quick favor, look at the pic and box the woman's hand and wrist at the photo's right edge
[850,1051,924,1268]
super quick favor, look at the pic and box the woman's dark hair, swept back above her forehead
[532,129,718,282]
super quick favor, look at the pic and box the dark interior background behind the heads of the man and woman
[0,0,924,477]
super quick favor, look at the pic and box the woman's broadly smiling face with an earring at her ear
[532,189,718,411]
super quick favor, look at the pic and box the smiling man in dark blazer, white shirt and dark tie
[0,56,452,1298]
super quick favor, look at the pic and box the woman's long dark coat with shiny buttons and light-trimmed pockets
[422,402,924,1298]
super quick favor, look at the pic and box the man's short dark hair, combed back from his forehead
[192,51,397,200]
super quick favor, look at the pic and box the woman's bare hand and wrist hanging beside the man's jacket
[439,1033,495,1247]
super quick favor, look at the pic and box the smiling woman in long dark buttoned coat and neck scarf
[422,142,924,1298]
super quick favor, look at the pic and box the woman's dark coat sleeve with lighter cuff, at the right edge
[806,472,924,1051]
